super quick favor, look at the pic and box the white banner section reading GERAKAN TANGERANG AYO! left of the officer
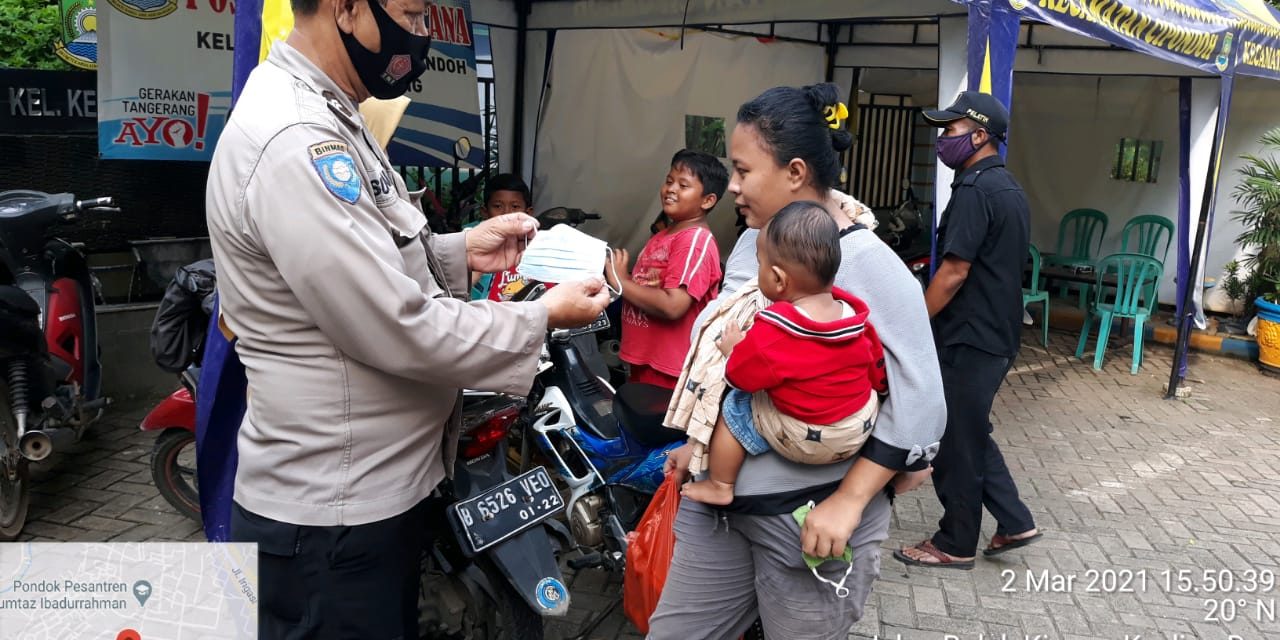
[97,0,236,161]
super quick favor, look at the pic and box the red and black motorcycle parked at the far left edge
[0,191,119,540]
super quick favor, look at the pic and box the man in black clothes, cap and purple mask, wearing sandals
[893,91,1041,568]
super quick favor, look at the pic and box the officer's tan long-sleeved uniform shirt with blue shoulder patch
[206,42,547,526]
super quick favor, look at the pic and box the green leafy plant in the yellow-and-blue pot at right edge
[1231,128,1280,310]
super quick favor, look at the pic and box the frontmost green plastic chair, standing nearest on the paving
[1075,253,1165,374]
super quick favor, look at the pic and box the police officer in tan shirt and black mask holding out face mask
[206,0,608,639]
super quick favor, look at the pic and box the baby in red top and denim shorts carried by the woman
[684,202,888,504]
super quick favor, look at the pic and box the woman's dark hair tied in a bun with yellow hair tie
[737,82,854,191]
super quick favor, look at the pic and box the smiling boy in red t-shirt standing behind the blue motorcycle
[605,148,728,389]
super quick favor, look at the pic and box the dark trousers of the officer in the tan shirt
[232,500,429,640]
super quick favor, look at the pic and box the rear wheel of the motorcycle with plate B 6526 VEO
[419,557,543,640]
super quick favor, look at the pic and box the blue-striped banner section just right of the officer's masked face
[387,0,484,166]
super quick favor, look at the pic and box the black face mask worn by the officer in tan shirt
[338,0,431,100]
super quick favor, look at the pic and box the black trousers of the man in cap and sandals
[933,344,1036,557]
